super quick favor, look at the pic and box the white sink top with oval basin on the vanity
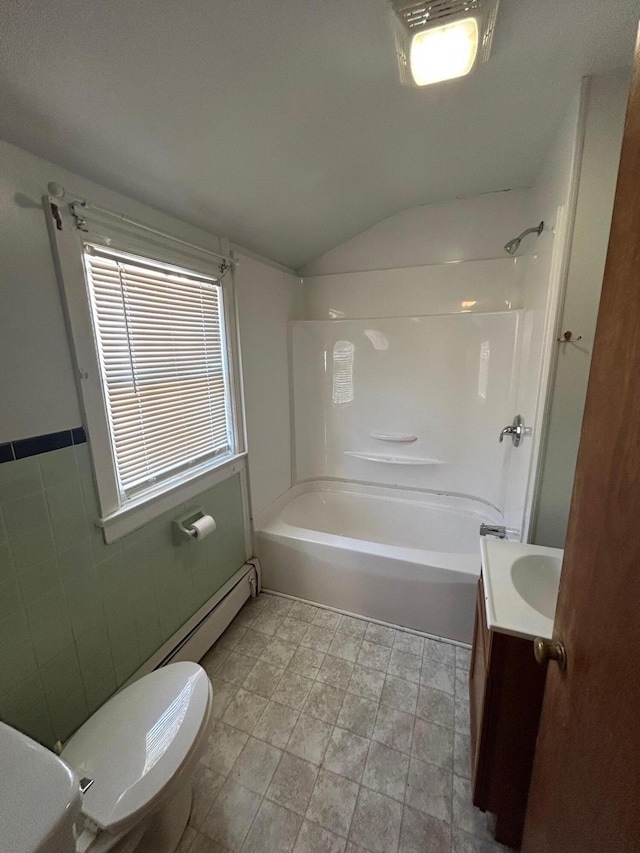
[480,536,564,640]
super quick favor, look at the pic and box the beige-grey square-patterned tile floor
[178,594,506,853]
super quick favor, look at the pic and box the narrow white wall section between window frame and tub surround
[235,255,300,516]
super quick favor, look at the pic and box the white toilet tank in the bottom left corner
[0,723,81,853]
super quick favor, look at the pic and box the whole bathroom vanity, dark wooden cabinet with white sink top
[469,537,563,849]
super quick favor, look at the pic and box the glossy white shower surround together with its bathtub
[255,258,535,642]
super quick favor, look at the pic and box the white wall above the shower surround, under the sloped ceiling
[300,190,530,277]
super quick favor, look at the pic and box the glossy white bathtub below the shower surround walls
[255,480,503,643]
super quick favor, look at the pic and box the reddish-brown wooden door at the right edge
[522,21,640,853]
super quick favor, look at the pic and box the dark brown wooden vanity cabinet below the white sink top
[469,578,546,849]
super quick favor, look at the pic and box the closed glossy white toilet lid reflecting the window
[61,661,211,832]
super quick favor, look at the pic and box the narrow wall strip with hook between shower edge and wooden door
[534,71,629,547]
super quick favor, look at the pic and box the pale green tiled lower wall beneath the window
[0,444,245,746]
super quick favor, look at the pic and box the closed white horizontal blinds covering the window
[84,244,233,502]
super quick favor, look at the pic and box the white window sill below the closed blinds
[96,452,247,545]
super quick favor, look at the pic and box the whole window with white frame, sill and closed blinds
[51,200,242,541]
